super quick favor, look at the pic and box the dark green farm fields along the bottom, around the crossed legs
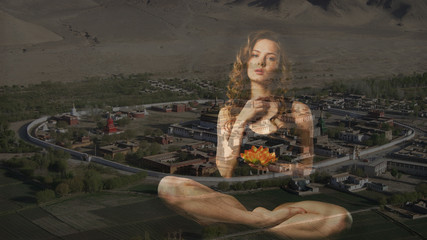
[0,169,427,240]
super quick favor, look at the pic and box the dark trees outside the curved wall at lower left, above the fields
[3,149,146,203]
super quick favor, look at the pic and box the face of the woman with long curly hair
[248,39,280,83]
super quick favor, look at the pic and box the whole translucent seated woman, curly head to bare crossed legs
[158,31,351,238]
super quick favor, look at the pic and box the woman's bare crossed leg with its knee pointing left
[158,176,305,228]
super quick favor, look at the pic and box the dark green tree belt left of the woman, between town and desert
[0,73,225,122]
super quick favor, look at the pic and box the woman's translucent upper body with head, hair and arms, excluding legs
[217,31,313,177]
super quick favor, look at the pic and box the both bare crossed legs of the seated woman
[158,176,352,239]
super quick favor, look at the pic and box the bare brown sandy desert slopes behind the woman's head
[0,0,427,87]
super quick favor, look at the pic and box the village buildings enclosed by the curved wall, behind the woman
[29,90,427,221]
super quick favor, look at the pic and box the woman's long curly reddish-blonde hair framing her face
[226,30,290,122]
